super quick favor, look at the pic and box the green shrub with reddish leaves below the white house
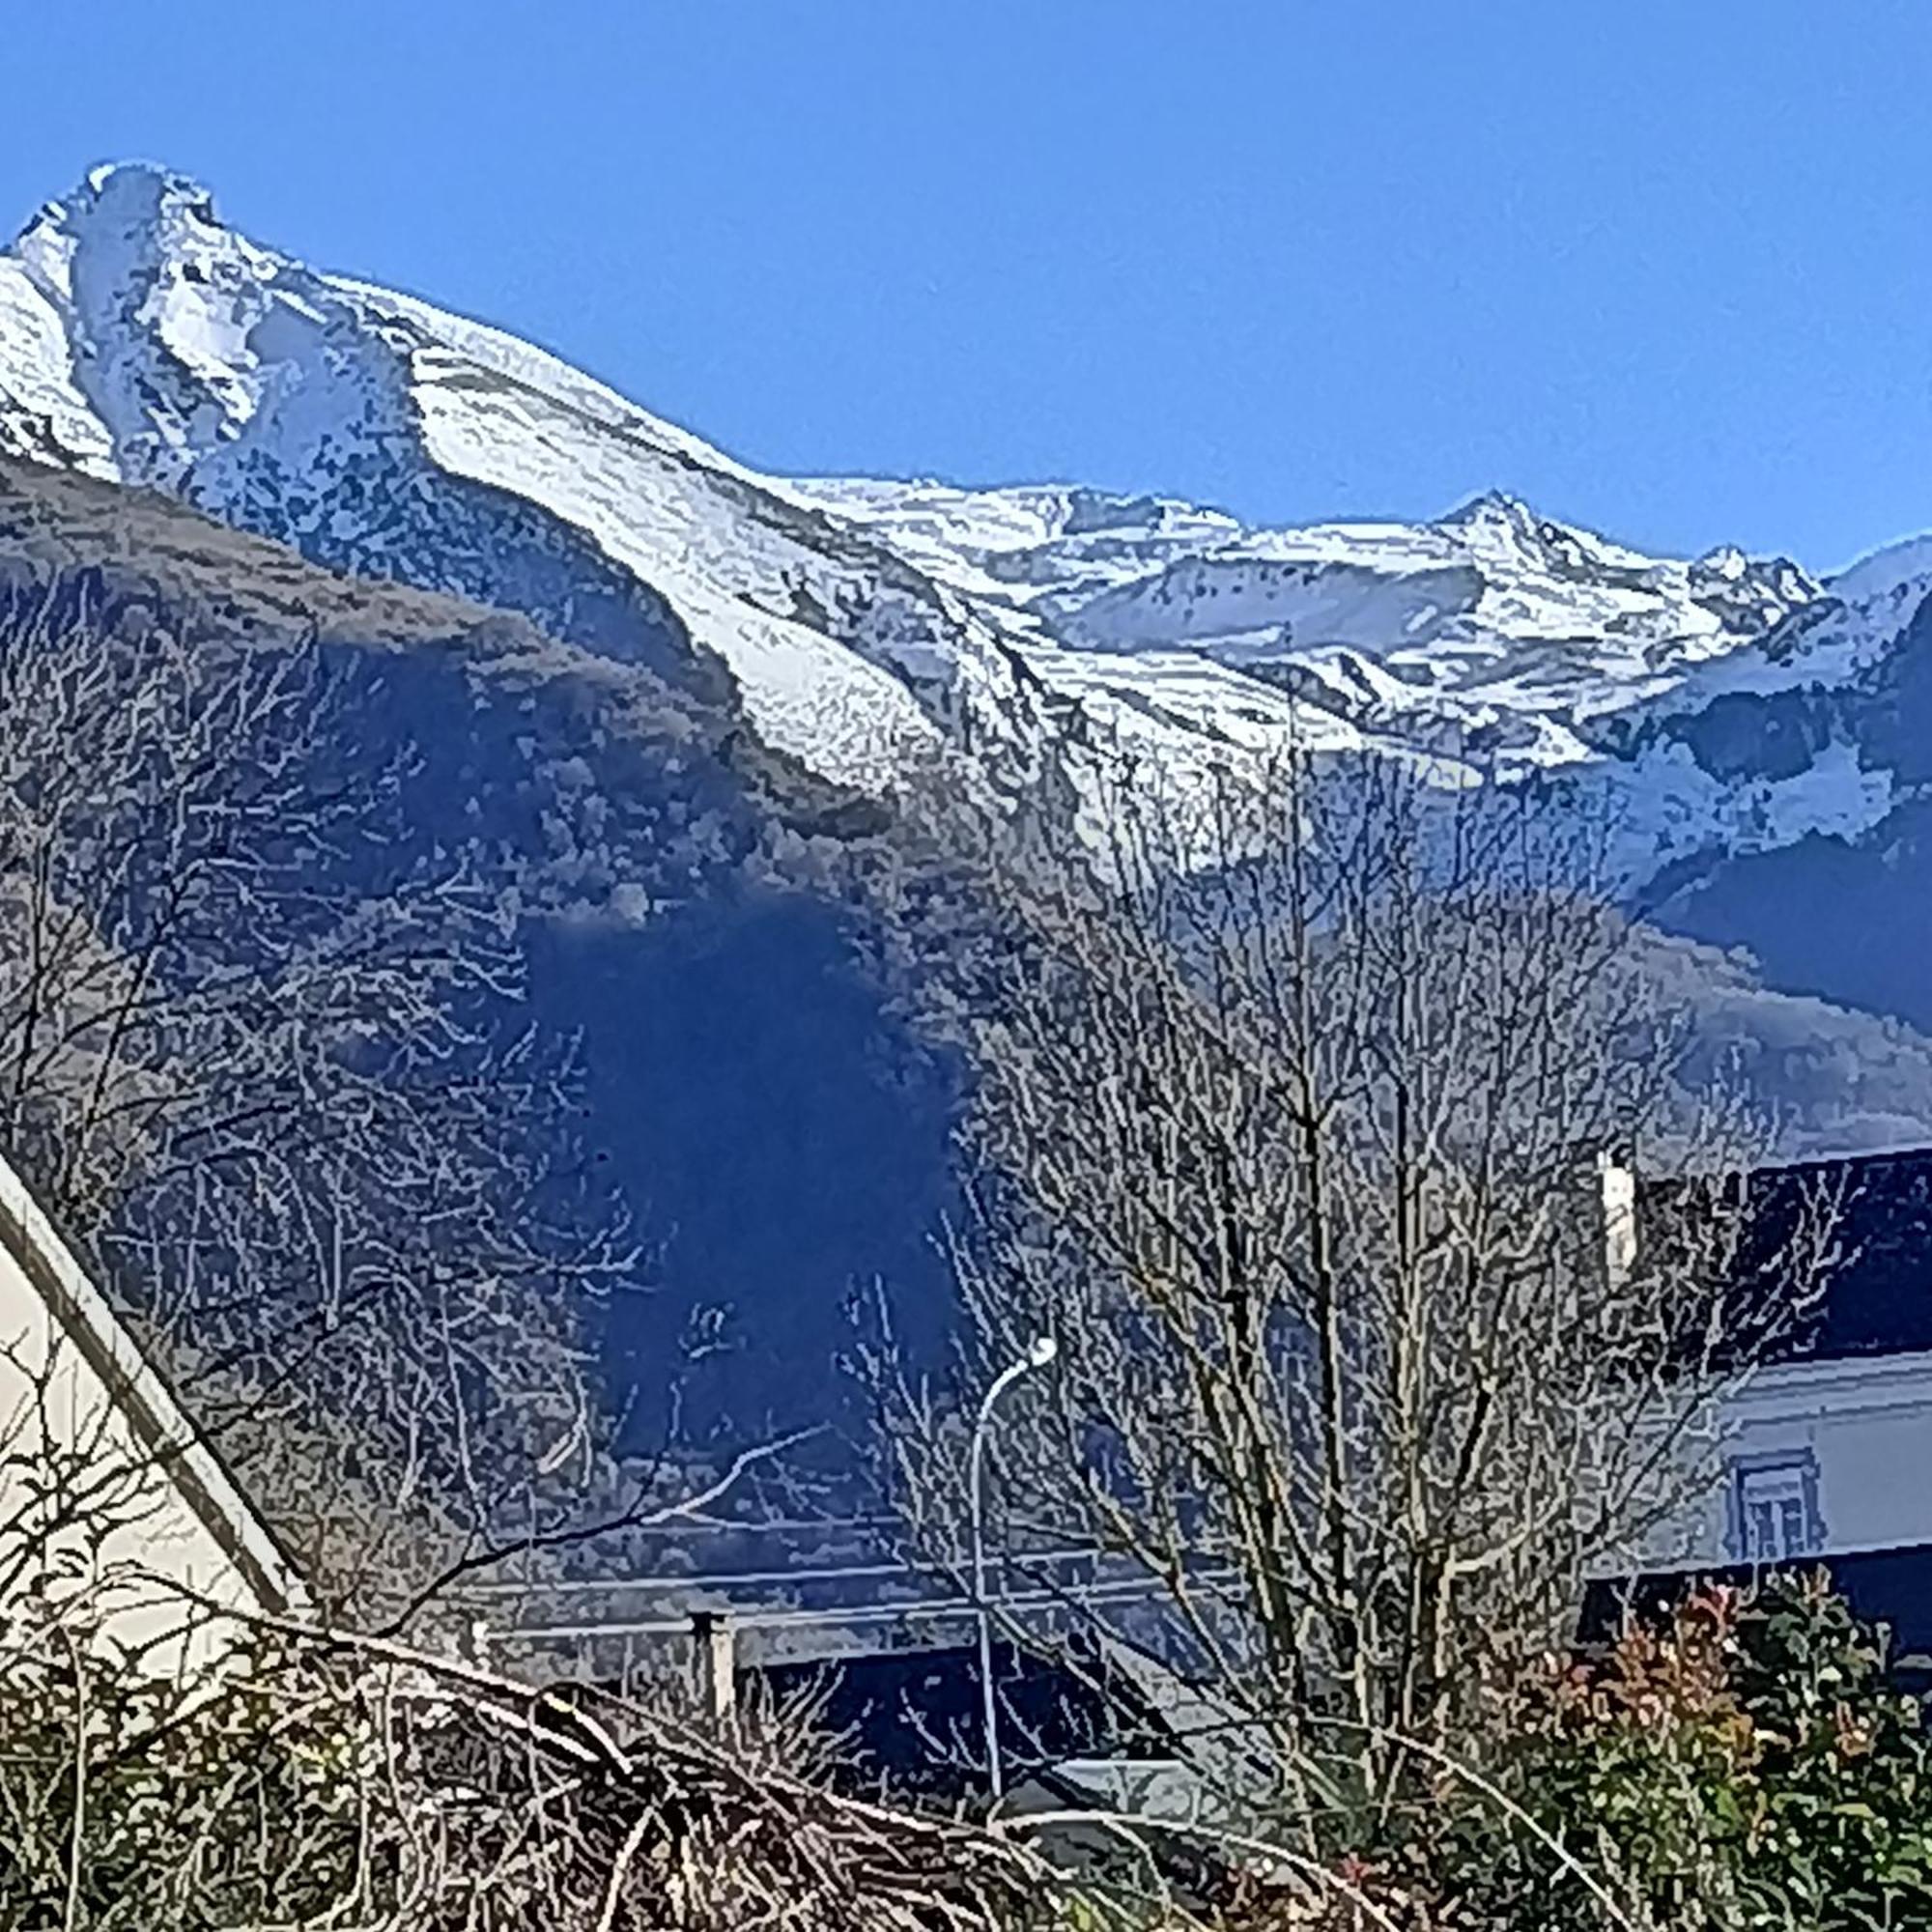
[1401,1577,1932,1932]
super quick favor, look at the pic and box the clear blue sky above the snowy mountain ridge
[0,0,1932,568]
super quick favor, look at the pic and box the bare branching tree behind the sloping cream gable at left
[0,578,665,1631]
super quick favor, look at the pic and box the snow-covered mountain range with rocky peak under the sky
[0,166,1932,879]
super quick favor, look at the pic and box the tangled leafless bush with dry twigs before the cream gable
[0,1406,1055,1932]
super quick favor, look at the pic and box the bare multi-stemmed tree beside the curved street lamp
[869,752,1826,1839]
